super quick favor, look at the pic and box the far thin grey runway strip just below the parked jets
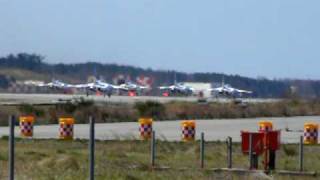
[0,94,278,105]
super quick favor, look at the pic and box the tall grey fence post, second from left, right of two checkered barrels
[89,116,95,180]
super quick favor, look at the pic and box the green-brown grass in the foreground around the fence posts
[0,139,320,180]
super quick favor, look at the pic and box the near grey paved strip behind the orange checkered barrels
[0,116,320,143]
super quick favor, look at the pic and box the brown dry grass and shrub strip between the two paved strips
[0,100,320,126]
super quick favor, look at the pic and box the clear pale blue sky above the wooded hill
[0,0,320,79]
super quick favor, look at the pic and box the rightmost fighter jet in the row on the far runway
[208,80,252,97]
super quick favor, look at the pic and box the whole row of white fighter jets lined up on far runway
[38,77,252,97]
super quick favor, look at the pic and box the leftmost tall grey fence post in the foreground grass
[9,116,15,180]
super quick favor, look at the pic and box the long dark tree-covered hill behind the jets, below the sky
[0,53,320,98]
